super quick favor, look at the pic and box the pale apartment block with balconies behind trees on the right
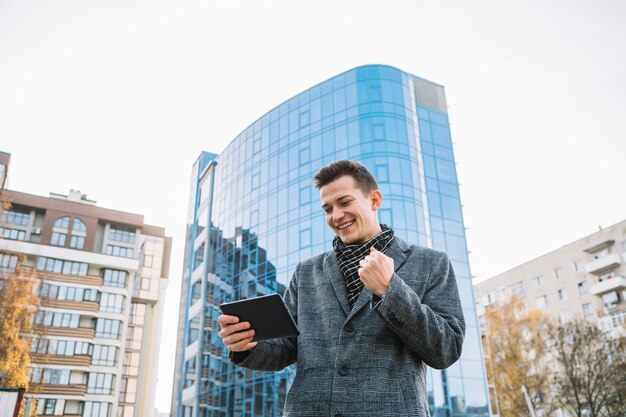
[474,220,626,336]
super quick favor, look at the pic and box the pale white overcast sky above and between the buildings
[0,0,626,411]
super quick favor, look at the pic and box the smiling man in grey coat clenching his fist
[219,161,465,417]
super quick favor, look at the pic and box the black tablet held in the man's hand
[220,294,300,341]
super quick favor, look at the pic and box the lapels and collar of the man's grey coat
[324,235,411,319]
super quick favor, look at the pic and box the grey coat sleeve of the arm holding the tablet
[229,264,300,371]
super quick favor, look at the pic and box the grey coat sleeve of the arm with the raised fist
[371,252,465,369]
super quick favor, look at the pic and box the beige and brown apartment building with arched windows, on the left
[0,153,171,417]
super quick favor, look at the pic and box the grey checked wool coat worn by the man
[231,236,465,417]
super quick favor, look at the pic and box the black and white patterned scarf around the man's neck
[333,224,394,307]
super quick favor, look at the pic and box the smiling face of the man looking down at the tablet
[320,175,382,244]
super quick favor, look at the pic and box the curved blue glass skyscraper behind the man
[172,65,489,417]
